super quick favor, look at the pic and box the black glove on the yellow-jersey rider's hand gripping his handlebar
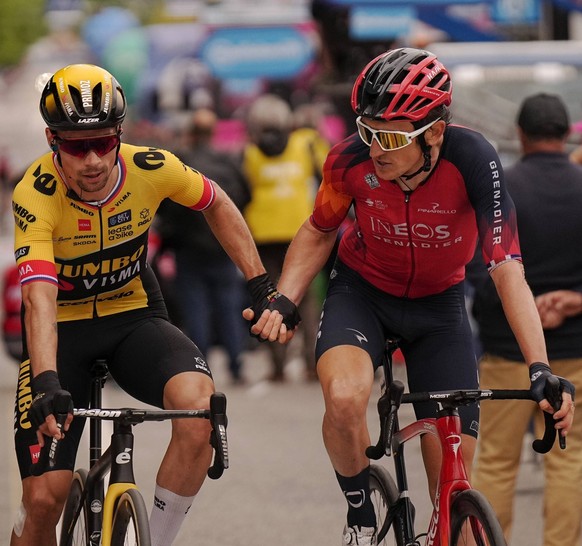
[29,370,73,429]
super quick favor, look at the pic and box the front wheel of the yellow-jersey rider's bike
[111,489,151,546]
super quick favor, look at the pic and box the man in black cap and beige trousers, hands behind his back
[468,94,582,546]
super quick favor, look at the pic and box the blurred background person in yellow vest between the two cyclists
[243,94,329,381]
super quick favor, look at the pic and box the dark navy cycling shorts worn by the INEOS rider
[315,261,479,437]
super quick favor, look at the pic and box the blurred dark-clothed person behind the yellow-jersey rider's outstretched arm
[157,109,250,383]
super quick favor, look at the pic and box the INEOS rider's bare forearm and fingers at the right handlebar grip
[491,261,574,435]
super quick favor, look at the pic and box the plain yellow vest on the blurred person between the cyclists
[243,130,325,244]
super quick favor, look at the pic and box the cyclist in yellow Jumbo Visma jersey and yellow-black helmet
[11,65,299,546]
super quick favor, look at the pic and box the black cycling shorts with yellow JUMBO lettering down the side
[14,308,212,479]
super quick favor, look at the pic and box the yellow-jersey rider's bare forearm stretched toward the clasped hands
[203,184,265,280]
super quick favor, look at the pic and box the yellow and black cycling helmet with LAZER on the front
[40,64,127,131]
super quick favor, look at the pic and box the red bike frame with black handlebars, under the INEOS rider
[366,339,566,546]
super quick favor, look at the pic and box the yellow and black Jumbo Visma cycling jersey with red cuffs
[12,144,215,322]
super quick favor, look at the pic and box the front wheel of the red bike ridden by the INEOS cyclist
[450,489,506,546]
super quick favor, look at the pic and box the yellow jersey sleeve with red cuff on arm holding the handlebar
[12,171,60,284]
